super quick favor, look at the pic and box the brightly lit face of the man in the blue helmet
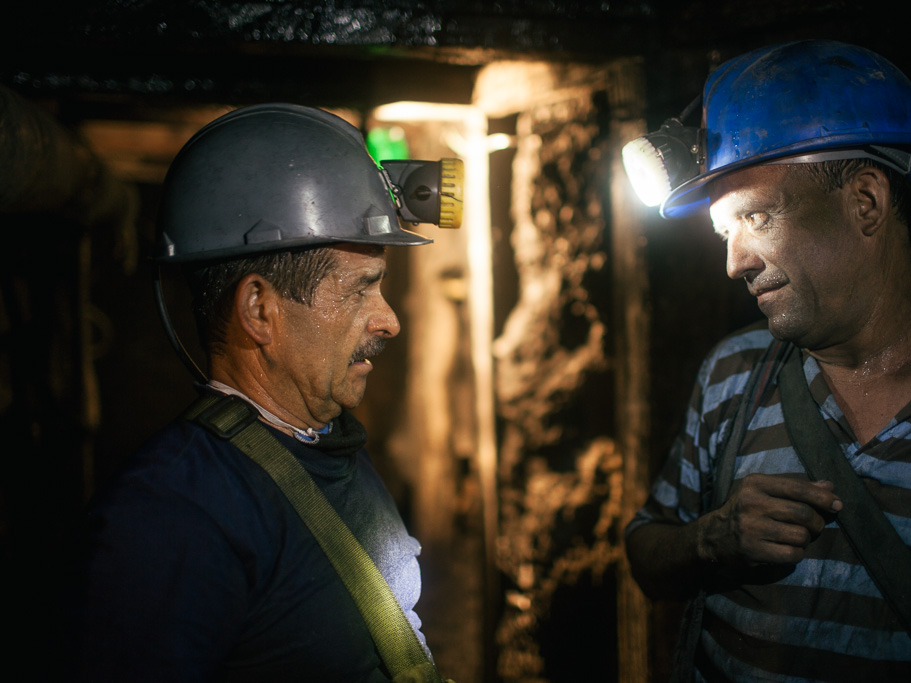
[711,165,871,349]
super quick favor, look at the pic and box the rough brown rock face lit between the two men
[494,91,623,681]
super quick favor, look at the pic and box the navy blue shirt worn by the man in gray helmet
[67,412,432,683]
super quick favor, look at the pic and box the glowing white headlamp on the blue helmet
[621,98,705,206]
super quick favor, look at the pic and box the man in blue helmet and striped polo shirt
[627,41,911,681]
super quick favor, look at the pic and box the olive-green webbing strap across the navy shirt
[184,395,442,683]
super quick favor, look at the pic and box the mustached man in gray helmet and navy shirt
[68,104,457,683]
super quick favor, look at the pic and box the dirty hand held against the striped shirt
[696,474,842,566]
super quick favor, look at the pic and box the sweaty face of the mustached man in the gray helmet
[269,244,400,426]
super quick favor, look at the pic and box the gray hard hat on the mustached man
[158,104,432,263]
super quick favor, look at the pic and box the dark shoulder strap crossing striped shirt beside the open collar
[780,349,911,633]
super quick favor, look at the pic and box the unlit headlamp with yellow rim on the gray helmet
[380,159,465,228]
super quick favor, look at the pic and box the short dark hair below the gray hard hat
[187,246,337,356]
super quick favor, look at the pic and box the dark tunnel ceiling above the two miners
[0,0,908,112]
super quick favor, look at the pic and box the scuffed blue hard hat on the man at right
[661,40,911,218]
